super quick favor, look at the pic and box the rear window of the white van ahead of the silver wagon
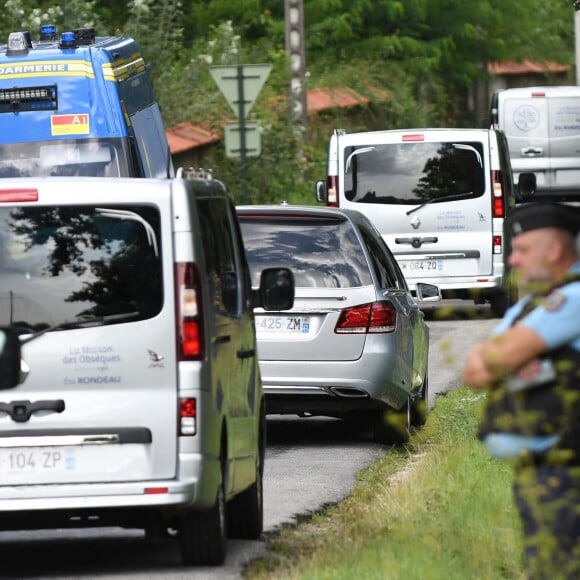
[343,142,485,205]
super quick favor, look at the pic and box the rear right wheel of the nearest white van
[177,464,227,566]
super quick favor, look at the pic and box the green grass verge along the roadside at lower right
[244,389,524,580]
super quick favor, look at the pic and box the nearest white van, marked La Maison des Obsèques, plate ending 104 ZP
[0,172,293,565]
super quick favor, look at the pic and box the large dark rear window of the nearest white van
[0,204,163,333]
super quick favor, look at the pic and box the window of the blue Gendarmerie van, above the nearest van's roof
[0,139,134,178]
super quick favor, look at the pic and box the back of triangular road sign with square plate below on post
[210,64,272,201]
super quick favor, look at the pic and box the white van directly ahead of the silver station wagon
[316,128,517,315]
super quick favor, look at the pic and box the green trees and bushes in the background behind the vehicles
[0,0,577,200]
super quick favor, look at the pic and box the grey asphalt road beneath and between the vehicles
[0,302,497,580]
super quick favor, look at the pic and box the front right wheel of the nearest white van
[227,414,265,540]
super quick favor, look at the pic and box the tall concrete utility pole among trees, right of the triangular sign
[284,0,308,130]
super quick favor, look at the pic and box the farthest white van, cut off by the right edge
[490,86,580,201]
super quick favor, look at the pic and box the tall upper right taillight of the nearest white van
[175,262,205,360]
